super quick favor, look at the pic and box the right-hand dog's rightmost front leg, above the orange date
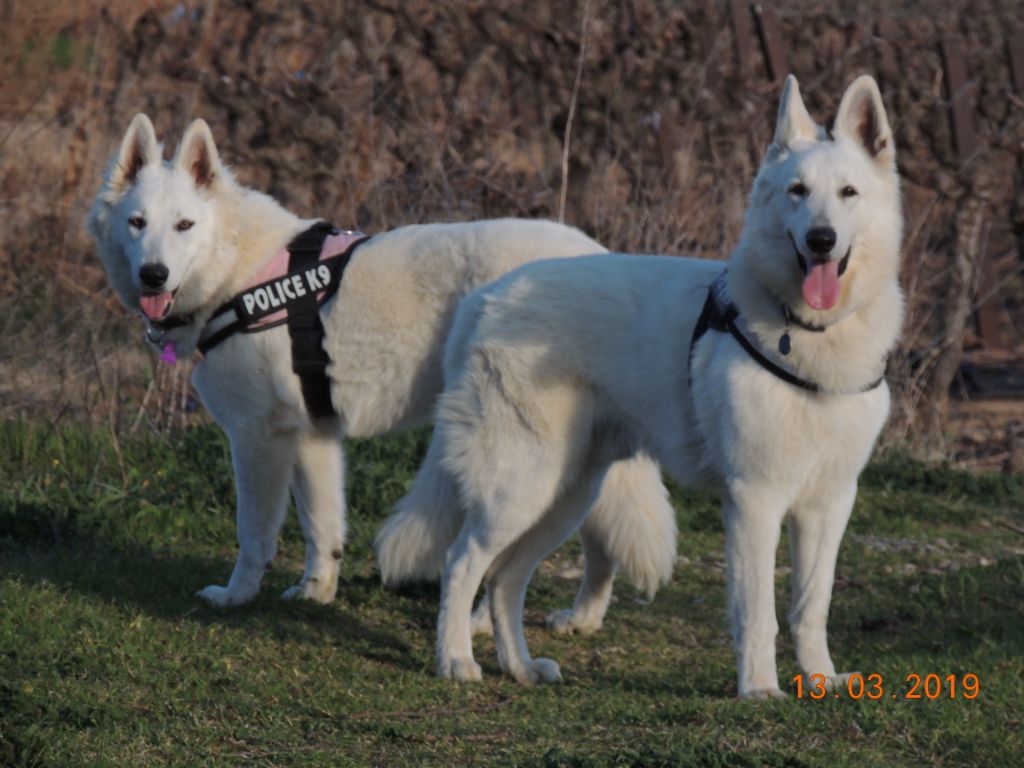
[790,482,857,689]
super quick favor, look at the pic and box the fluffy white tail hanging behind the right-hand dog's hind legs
[374,439,463,587]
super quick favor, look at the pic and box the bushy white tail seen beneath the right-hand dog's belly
[584,454,677,598]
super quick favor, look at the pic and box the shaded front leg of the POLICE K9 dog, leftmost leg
[199,421,297,607]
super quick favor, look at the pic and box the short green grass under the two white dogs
[0,422,1024,767]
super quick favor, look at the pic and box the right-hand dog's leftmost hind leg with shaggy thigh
[434,350,593,680]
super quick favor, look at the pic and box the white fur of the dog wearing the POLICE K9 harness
[88,115,676,618]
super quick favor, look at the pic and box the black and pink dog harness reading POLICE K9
[199,221,370,418]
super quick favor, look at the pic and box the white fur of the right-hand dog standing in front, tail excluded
[385,77,902,697]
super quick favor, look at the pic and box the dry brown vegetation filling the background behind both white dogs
[0,0,1024,464]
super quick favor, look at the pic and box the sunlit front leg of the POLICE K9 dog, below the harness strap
[282,419,345,603]
